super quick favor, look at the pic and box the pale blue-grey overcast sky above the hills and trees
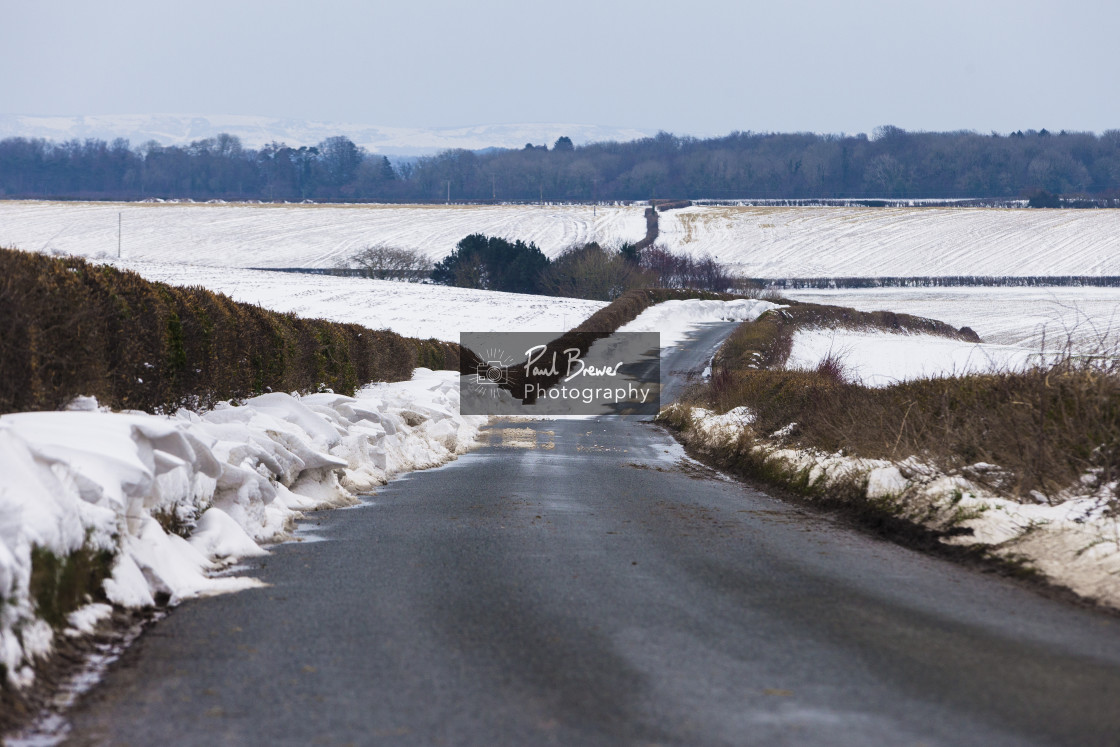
[0,0,1120,136]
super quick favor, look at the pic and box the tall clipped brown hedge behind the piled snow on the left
[0,249,459,412]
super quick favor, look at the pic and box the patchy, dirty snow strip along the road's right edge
[662,404,1120,608]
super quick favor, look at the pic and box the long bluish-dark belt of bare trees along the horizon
[0,127,1120,201]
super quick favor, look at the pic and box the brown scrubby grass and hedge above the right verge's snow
[691,297,1120,499]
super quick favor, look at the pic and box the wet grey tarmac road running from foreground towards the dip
[63,328,1120,745]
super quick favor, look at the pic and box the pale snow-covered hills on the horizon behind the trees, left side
[0,114,654,156]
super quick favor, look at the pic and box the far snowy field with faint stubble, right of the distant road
[658,206,1120,278]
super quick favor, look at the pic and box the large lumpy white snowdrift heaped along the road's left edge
[0,368,485,687]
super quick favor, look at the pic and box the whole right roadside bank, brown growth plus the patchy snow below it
[660,305,1120,608]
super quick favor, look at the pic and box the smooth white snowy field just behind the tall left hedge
[108,260,606,343]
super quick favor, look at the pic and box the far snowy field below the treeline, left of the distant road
[0,202,645,268]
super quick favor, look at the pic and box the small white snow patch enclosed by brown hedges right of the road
[786,329,1038,386]
